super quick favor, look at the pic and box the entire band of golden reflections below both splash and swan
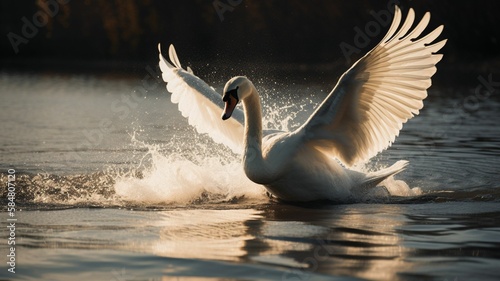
[139,204,412,280]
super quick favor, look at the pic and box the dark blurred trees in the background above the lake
[0,0,500,73]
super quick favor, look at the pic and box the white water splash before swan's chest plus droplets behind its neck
[114,90,304,204]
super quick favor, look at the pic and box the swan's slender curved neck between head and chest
[242,85,273,184]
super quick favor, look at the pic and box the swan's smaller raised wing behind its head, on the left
[158,44,244,154]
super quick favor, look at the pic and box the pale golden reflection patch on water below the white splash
[146,209,260,261]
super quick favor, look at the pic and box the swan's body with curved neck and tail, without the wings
[223,76,407,202]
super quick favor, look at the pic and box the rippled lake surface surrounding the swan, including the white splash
[0,73,500,280]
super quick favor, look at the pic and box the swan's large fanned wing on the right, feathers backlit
[298,6,446,166]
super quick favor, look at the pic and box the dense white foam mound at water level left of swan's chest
[115,142,266,204]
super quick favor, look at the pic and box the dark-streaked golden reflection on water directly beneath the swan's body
[262,205,411,280]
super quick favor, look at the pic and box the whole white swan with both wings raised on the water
[158,6,446,202]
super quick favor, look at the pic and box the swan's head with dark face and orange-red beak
[222,76,253,120]
